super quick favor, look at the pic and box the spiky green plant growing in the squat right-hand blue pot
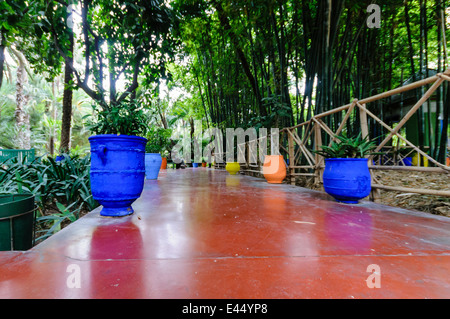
[313,133,384,158]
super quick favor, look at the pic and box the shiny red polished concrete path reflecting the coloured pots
[0,168,450,299]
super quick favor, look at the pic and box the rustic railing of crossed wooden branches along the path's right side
[230,69,450,199]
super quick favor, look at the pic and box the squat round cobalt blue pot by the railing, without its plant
[323,158,372,204]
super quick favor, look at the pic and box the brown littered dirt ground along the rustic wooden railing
[297,171,450,217]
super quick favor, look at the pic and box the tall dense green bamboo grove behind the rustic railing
[174,0,450,161]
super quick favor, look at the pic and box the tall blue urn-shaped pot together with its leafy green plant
[89,100,149,217]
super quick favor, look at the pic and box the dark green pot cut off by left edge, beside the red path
[0,194,35,251]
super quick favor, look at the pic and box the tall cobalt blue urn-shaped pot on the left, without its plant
[89,134,147,217]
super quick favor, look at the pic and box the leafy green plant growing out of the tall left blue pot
[87,100,150,136]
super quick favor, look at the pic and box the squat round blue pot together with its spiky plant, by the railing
[314,133,382,204]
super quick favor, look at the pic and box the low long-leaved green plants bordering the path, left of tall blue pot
[0,154,98,240]
